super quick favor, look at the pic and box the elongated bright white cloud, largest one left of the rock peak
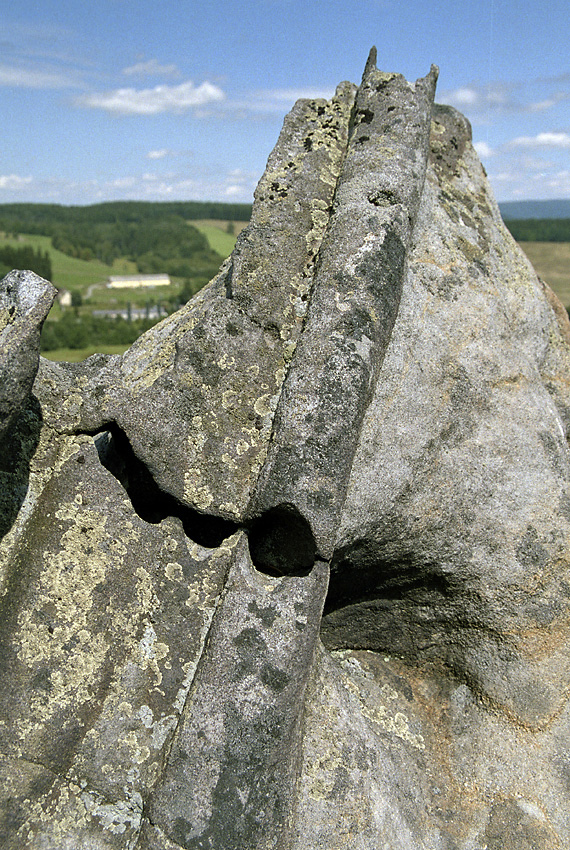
[76,80,225,115]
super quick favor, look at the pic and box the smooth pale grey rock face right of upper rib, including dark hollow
[324,102,570,727]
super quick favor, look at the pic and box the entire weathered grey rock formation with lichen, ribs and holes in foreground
[0,53,570,850]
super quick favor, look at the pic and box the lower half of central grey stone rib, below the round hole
[143,539,328,850]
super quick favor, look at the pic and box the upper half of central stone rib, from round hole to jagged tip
[246,54,437,560]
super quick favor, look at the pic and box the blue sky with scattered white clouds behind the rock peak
[0,0,570,204]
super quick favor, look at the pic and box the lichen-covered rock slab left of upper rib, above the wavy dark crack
[34,83,355,521]
